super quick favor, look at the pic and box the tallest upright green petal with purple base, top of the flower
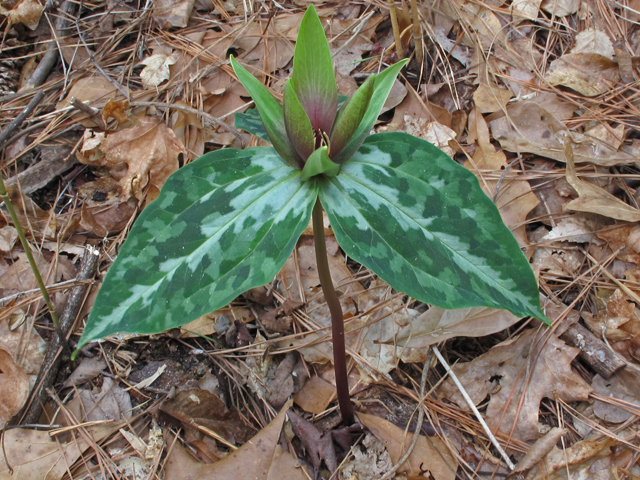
[291,5,338,133]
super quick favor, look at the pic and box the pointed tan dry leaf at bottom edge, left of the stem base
[164,401,307,480]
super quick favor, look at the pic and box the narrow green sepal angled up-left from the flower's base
[229,55,304,168]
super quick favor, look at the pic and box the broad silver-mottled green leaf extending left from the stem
[80,147,318,346]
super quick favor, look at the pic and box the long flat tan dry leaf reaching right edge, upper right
[489,101,637,166]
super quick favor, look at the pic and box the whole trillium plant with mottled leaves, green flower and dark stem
[79,6,548,423]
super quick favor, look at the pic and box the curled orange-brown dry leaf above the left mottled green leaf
[87,117,185,201]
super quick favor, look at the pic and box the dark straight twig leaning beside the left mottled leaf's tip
[20,245,100,423]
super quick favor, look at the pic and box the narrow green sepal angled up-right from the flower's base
[333,59,409,165]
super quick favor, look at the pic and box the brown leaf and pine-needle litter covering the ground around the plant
[0,0,640,479]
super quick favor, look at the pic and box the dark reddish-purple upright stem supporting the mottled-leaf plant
[313,199,355,425]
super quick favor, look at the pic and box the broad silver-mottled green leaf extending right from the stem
[320,133,547,321]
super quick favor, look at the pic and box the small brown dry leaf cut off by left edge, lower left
[0,349,29,429]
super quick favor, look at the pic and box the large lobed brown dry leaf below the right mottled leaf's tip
[440,329,592,441]
